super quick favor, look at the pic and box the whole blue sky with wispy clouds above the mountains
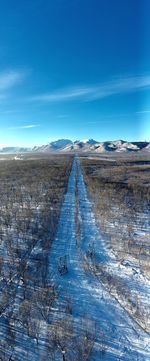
[0,0,150,146]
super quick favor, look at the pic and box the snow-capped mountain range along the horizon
[0,139,150,153]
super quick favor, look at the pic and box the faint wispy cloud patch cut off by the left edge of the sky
[0,70,25,92]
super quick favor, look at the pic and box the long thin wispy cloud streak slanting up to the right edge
[30,75,150,103]
